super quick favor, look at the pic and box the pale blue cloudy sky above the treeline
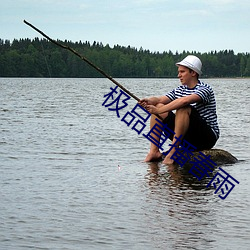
[0,0,250,53]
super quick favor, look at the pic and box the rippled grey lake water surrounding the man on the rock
[0,78,250,250]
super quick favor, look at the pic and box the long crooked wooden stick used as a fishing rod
[23,20,140,101]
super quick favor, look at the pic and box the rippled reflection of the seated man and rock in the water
[146,163,218,249]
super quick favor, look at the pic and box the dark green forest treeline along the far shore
[0,38,250,77]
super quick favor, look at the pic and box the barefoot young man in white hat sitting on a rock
[139,55,219,165]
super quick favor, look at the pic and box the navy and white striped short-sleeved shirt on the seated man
[166,81,220,139]
